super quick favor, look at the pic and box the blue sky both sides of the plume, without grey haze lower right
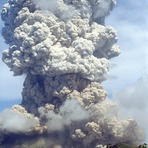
[0,0,148,116]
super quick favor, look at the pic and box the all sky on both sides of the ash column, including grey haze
[0,0,148,133]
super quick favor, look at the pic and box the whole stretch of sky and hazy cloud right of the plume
[104,0,148,142]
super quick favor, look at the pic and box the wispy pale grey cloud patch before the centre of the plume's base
[39,99,89,132]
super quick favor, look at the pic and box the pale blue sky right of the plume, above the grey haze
[105,0,148,91]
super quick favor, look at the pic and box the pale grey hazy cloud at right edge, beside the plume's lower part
[113,75,148,142]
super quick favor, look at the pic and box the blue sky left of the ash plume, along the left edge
[0,0,23,110]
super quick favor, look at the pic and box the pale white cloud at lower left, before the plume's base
[0,105,39,133]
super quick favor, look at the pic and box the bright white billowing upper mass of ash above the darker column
[2,1,119,81]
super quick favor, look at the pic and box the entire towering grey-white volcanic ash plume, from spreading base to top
[0,0,144,148]
